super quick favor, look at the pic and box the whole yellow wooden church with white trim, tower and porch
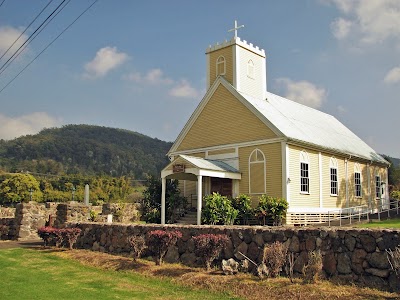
[161,22,389,224]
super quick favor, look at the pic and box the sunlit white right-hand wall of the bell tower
[238,47,265,98]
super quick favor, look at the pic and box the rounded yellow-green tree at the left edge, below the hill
[0,173,43,203]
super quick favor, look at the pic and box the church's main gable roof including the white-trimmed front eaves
[168,76,389,165]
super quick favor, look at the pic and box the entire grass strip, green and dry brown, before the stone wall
[0,249,400,300]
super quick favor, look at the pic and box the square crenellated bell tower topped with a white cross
[206,21,267,99]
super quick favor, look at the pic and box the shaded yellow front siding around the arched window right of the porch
[239,143,282,205]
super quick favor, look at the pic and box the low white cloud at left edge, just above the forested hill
[0,112,61,140]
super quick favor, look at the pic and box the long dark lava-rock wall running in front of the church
[70,223,400,289]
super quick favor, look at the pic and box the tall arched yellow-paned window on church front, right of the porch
[249,149,266,194]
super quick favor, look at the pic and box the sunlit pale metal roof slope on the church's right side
[239,92,388,164]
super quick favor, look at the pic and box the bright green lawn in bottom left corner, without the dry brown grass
[0,248,237,300]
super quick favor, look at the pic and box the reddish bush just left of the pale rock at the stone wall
[193,233,229,270]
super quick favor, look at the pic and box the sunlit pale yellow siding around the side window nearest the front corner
[289,145,320,208]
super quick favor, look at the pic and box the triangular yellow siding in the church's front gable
[178,86,276,151]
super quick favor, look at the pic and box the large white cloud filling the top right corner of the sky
[331,0,400,44]
